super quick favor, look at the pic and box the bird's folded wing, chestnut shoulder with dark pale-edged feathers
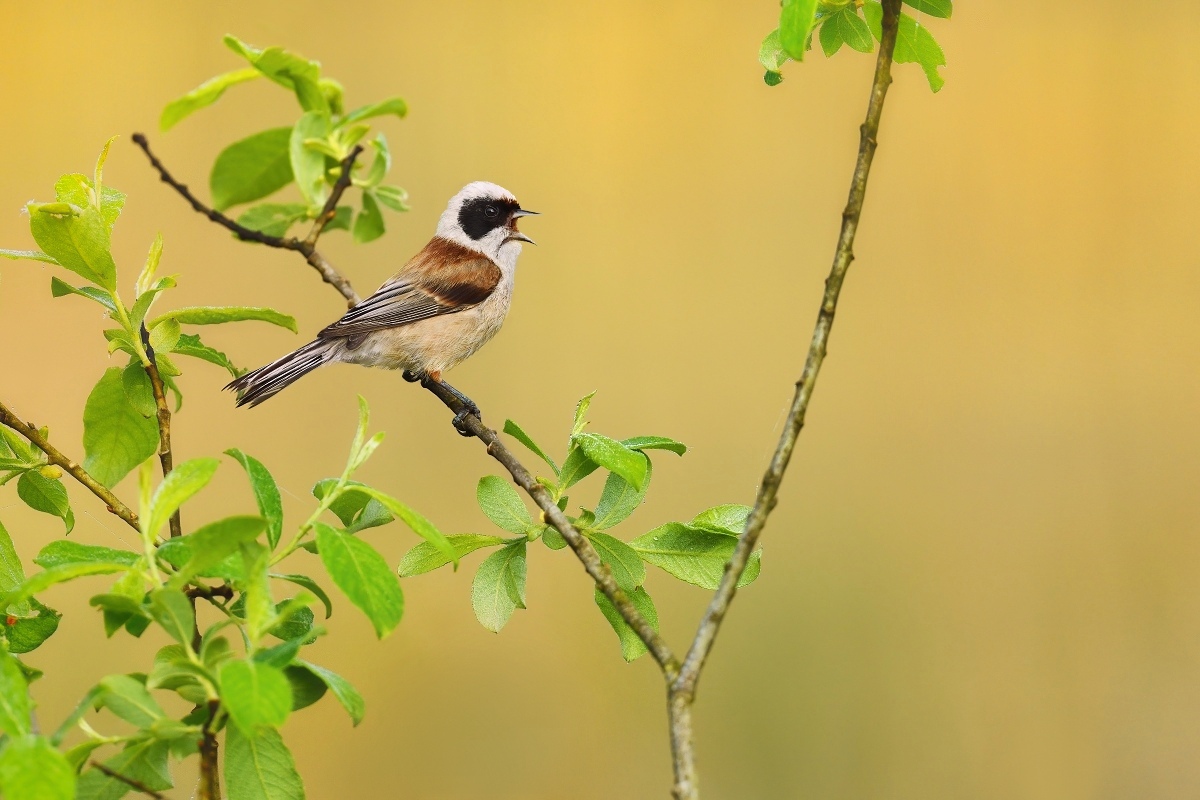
[318,237,502,338]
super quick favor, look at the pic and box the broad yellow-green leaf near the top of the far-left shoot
[25,203,116,291]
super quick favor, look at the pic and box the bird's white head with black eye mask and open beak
[438,181,538,266]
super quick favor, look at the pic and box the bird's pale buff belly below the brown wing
[346,299,505,373]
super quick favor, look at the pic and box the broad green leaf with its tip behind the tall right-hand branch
[629,522,762,589]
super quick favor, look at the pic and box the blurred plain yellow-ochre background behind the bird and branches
[0,0,1200,800]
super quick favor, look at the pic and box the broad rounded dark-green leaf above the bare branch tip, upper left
[209,128,292,211]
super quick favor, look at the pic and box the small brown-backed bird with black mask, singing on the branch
[226,181,536,432]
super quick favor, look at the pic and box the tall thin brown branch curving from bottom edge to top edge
[667,0,900,800]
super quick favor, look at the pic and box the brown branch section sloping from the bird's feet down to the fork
[424,380,679,681]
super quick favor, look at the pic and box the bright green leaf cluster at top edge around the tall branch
[758,0,954,92]
